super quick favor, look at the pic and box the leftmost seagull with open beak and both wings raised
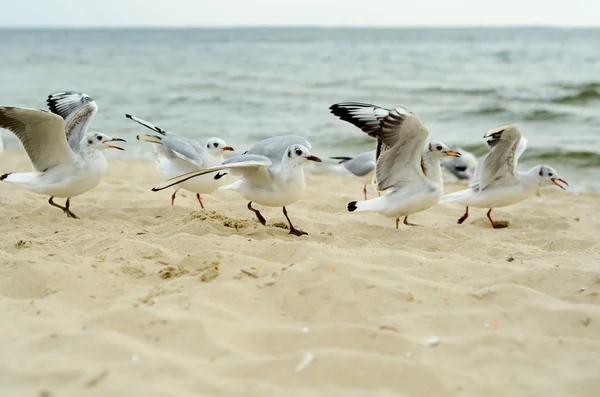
[0,91,125,218]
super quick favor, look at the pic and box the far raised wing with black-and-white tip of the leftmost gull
[46,91,98,153]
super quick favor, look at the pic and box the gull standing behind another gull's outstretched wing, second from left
[125,114,233,209]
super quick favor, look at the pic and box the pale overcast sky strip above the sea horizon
[0,0,600,27]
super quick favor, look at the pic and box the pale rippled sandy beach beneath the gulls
[0,151,600,397]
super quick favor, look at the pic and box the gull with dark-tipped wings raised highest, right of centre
[329,102,460,229]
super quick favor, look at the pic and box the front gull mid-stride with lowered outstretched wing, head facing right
[152,135,321,237]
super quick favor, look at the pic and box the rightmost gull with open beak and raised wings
[441,124,569,229]
